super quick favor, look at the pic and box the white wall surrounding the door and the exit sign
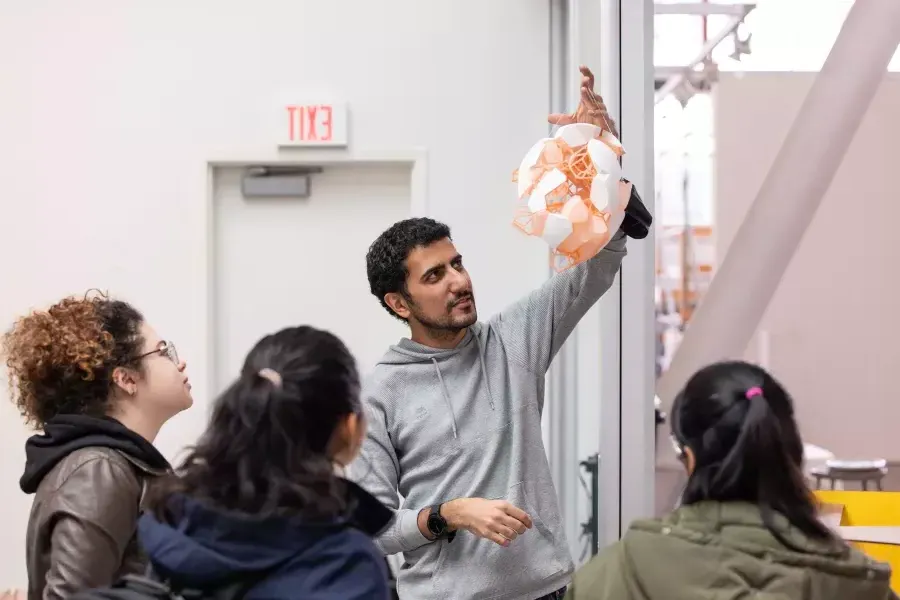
[0,0,549,587]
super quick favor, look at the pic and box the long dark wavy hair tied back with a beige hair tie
[148,327,361,521]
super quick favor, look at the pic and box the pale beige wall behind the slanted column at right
[714,73,900,461]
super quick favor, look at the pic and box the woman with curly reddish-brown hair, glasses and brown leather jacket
[2,293,192,600]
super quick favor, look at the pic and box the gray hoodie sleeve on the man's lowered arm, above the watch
[349,398,431,555]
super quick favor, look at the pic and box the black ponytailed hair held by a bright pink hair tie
[672,361,837,550]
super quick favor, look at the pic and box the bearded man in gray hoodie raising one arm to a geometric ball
[351,65,625,600]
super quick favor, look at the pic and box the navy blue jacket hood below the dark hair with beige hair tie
[138,481,393,597]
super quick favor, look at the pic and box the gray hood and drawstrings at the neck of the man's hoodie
[378,323,497,438]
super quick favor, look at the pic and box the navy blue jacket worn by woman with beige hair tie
[138,482,393,600]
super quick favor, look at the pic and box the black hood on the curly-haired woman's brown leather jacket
[19,415,169,494]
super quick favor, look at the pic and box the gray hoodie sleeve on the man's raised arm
[491,230,627,376]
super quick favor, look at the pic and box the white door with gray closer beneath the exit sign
[213,164,410,394]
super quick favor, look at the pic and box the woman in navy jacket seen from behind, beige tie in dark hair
[138,327,392,600]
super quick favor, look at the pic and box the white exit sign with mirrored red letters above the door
[279,103,347,146]
